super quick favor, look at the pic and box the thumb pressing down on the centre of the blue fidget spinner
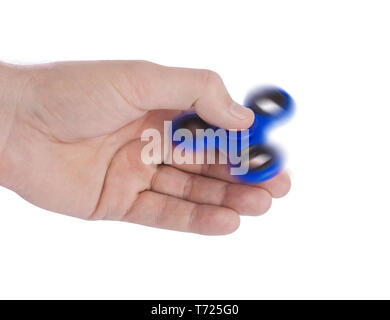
[131,62,254,129]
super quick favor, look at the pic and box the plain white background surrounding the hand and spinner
[0,0,390,299]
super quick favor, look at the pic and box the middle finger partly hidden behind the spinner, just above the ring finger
[173,164,291,198]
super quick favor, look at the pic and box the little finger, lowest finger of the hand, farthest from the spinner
[123,191,240,235]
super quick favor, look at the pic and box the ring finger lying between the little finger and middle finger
[151,166,272,215]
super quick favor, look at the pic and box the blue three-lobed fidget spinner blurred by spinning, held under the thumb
[172,87,294,183]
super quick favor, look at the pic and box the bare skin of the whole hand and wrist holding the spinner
[0,61,290,235]
